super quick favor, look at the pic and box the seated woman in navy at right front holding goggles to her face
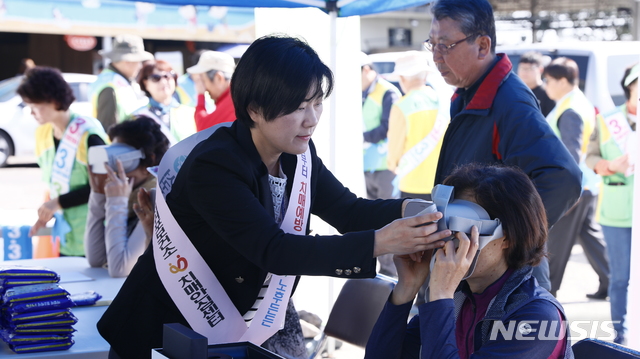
[365,164,572,359]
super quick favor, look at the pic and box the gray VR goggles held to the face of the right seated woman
[405,185,504,279]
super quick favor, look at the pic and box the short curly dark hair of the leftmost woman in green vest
[16,66,76,111]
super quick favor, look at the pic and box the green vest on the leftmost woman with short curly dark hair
[36,114,109,256]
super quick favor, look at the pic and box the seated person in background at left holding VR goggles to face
[84,117,169,277]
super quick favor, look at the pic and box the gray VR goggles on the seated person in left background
[88,143,145,174]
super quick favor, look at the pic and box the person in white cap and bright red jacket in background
[187,51,236,131]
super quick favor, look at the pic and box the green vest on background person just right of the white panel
[362,77,400,172]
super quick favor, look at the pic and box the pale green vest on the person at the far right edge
[597,104,634,228]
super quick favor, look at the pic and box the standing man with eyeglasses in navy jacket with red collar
[424,0,581,289]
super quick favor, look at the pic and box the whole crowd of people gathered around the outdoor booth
[18,0,640,358]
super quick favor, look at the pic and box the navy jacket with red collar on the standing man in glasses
[435,54,582,226]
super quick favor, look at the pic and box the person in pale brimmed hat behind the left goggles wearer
[89,35,153,129]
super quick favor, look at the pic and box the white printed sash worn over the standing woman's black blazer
[152,123,311,345]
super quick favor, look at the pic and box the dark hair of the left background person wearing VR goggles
[109,116,169,167]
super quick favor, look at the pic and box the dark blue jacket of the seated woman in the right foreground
[365,267,573,359]
